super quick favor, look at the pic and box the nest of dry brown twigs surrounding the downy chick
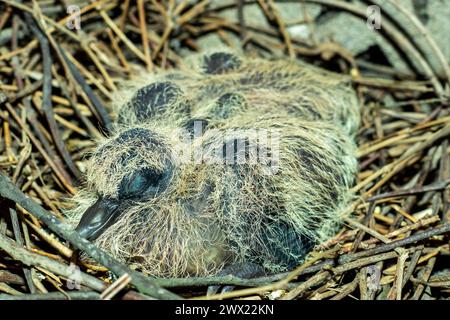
[0,0,450,300]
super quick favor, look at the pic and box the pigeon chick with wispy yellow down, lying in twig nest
[69,52,359,277]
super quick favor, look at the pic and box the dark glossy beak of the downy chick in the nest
[75,197,121,241]
